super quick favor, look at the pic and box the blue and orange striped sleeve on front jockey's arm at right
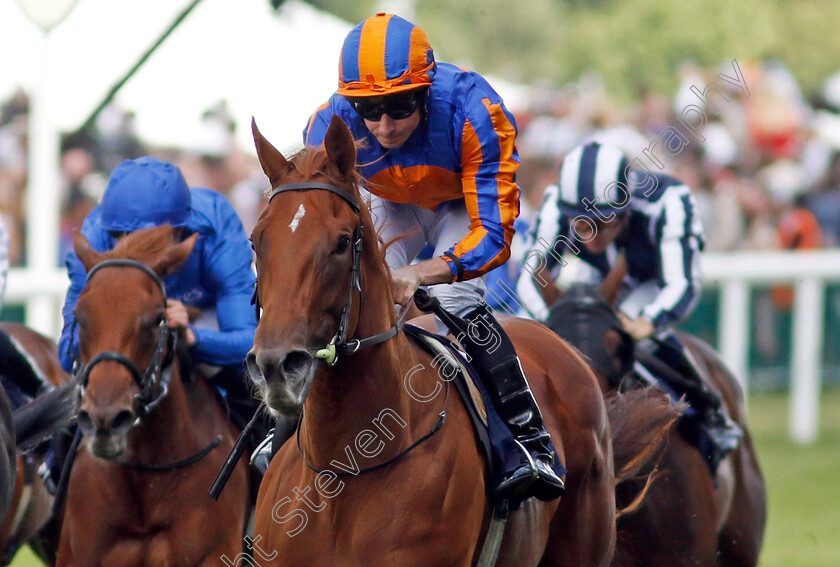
[443,95,519,281]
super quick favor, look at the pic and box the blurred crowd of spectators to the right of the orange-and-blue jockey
[519,61,840,258]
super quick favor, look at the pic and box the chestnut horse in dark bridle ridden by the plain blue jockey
[58,225,249,567]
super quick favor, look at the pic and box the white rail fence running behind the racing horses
[5,250,840,444]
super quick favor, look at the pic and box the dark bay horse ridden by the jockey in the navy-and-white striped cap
[546,285,767,567]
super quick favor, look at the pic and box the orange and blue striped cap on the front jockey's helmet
[336,12,435,97]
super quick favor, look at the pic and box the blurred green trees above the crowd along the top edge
[296,0,840,100]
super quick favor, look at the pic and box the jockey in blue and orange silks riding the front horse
[296,13,563,500]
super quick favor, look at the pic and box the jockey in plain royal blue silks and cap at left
[39,157,257,492]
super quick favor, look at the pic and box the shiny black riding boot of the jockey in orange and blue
[458,305,565,502]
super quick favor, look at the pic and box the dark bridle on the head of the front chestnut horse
[252,181,408,366]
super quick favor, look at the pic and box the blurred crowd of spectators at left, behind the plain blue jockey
[0,91,266,266]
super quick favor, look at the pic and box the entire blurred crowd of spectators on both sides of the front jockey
[0,61,840,272]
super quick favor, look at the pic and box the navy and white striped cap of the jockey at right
[559,142,630,219]
